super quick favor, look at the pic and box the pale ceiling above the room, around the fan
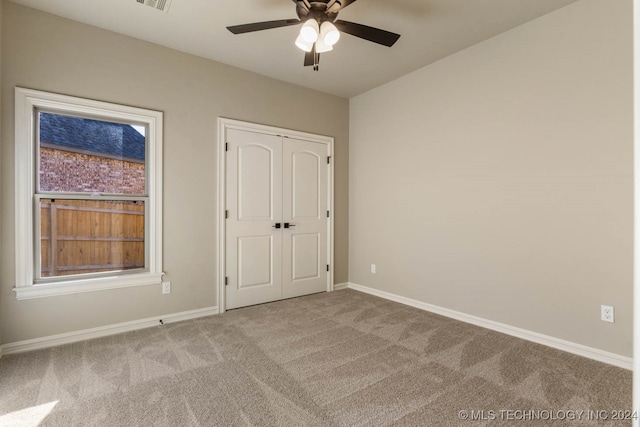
[12,0,576,98]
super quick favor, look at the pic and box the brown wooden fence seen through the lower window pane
[40,199,144,277]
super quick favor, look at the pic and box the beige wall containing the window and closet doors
[0,2,349,343]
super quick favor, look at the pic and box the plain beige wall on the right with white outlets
[349,0,633,356]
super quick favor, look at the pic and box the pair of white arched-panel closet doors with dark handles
[225,129,329,309]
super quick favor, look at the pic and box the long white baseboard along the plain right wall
[347,283,633,370]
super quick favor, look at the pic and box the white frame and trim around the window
[13,87,164,300]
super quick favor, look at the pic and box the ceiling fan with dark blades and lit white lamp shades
[227,0,400,71]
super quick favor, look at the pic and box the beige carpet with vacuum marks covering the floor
[0,290,631,427]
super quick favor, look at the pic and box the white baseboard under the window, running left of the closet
[0,307,218,357]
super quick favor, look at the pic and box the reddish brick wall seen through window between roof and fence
[40,147,145,194]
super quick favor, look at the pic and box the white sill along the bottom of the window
[13,273,164,300]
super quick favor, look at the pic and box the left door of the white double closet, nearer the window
[226,129,282,309]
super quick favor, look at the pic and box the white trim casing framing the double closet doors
[216,117,335,313]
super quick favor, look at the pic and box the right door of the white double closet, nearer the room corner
[282,138,329,298]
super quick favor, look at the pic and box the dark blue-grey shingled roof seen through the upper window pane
[40,112,145,160]
